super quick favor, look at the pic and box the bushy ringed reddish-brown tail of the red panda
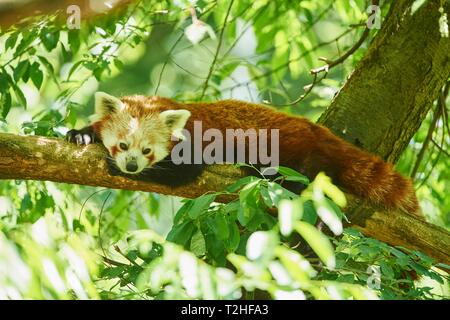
[311,126,422,216]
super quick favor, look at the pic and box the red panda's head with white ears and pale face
[91,92,191,174]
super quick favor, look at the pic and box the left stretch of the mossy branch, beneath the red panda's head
[0,133,241,198]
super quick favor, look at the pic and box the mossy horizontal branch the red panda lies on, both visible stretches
[0,133,450,264]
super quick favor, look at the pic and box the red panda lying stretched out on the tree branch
[67,92,420,215]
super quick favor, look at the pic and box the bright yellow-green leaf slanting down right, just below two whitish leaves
[294,221,336,269]
